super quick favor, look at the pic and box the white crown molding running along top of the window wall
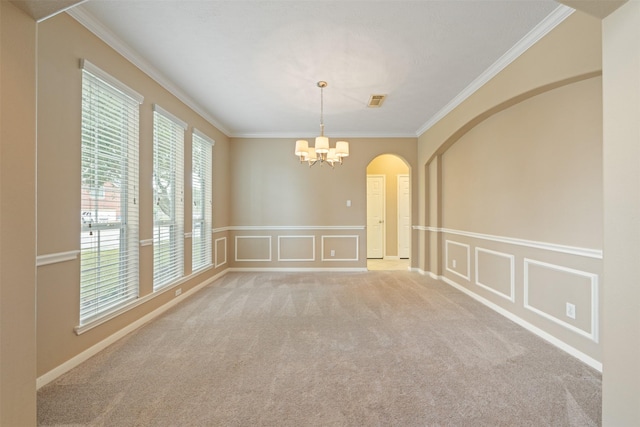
[66,5,231,136]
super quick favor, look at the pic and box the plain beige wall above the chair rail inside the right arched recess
[442,77,602,249]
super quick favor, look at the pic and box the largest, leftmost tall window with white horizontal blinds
[80,60,143,325]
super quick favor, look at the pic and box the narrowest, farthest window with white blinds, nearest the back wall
[191,129,213,271]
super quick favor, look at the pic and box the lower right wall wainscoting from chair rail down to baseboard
[414,226,604,370]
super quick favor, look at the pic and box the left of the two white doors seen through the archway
[367,175,384,258]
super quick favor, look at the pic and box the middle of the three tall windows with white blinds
[153,105,187,291]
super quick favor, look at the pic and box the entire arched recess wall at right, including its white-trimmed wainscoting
[440,77,603,361]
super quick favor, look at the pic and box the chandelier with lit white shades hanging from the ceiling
[295,81,349,167]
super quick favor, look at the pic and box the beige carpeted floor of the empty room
[38,271,601,427]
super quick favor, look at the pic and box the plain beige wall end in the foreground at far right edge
[602,1,640,426]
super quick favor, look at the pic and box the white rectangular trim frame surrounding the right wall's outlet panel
[524,258,598,343]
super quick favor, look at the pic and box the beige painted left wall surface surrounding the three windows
[37,14,229,376]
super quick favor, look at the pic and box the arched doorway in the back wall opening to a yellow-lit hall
[366,154,411,270]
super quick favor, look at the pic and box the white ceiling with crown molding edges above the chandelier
[71,0,571,138]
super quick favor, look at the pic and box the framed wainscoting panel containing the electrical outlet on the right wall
[524,258,598,342]
